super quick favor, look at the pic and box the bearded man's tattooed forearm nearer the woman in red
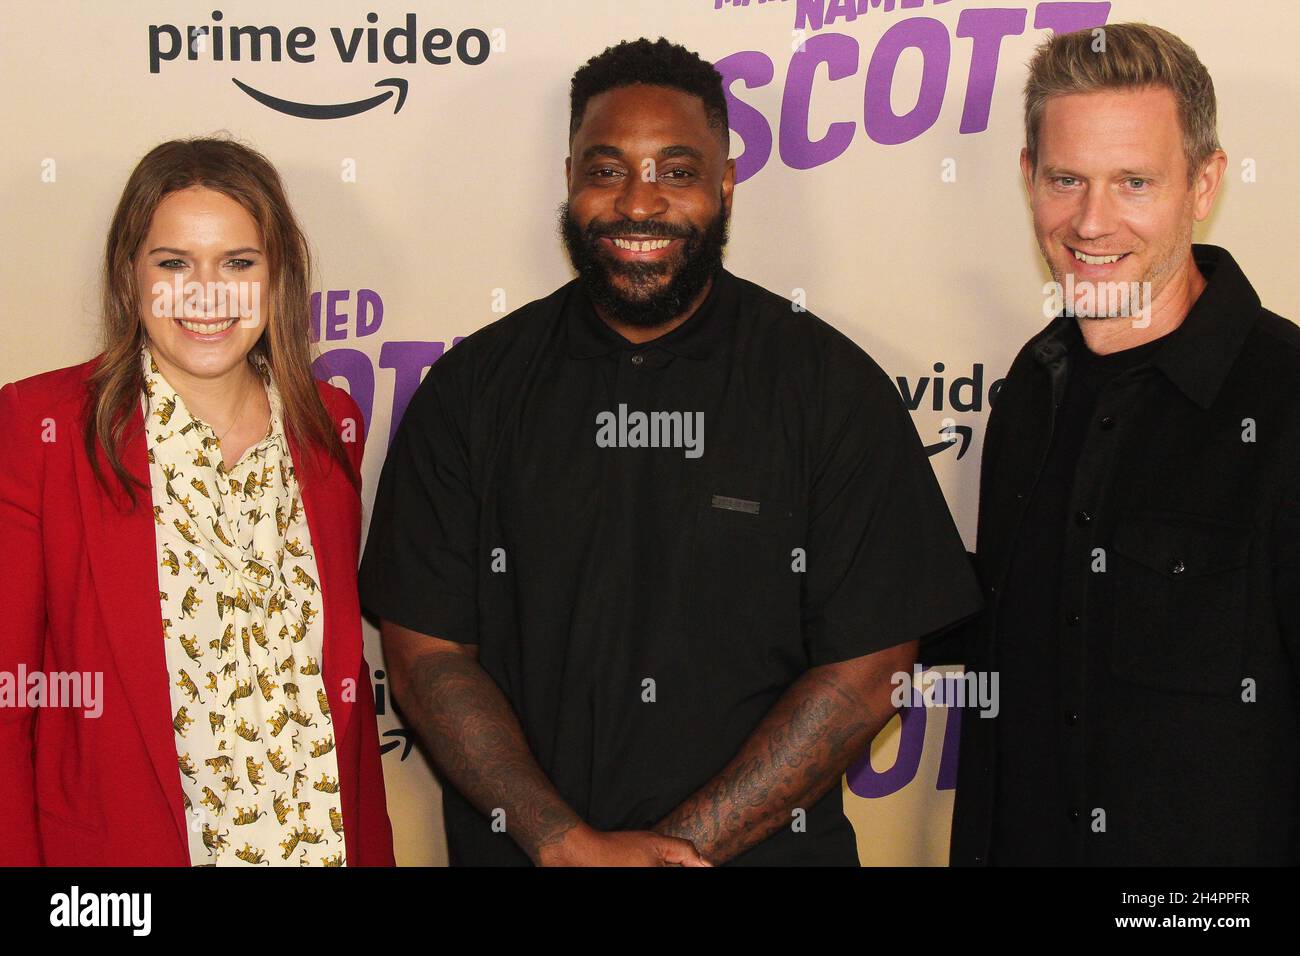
[394,642,581,864]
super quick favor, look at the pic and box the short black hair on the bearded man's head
[569,36,731,151]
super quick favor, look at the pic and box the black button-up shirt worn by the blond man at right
[953,246,1300,865]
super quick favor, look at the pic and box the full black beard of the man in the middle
[559,202,728,329]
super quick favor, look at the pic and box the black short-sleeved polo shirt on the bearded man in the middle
[361,271,979,864]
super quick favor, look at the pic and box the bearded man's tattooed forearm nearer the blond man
[655,644,915,864]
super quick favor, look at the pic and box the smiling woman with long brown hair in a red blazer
[0,138,393,866]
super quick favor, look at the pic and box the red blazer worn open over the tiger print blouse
[0,359,394,866]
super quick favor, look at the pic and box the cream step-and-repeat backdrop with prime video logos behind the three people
[0,0,1300,865]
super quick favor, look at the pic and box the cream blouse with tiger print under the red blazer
[140,346,345,866]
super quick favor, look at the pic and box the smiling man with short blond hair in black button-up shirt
[952,23,1300,865]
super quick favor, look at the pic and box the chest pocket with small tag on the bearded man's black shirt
[688,490,802,667]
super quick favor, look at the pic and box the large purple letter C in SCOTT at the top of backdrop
[780,34,858,169]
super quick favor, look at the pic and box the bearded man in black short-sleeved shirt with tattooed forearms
[361,39,979,865]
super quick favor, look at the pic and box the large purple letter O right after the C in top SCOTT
[865,17,952,146]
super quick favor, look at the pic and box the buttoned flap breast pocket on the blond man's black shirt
[1110,514,1251,697]
